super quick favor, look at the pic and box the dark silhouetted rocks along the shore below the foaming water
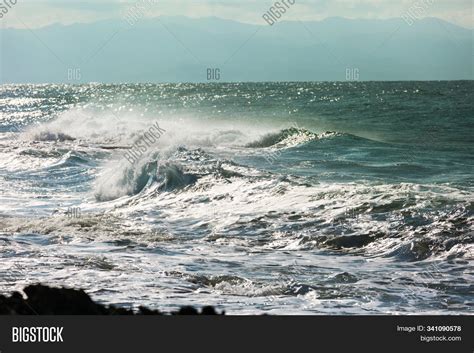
[0,284,224,315]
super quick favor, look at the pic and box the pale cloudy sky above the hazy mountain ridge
[0,0,474,28]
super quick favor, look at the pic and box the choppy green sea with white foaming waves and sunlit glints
[0,82,474,314]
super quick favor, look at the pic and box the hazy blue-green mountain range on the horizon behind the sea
[0,17,473,83]
